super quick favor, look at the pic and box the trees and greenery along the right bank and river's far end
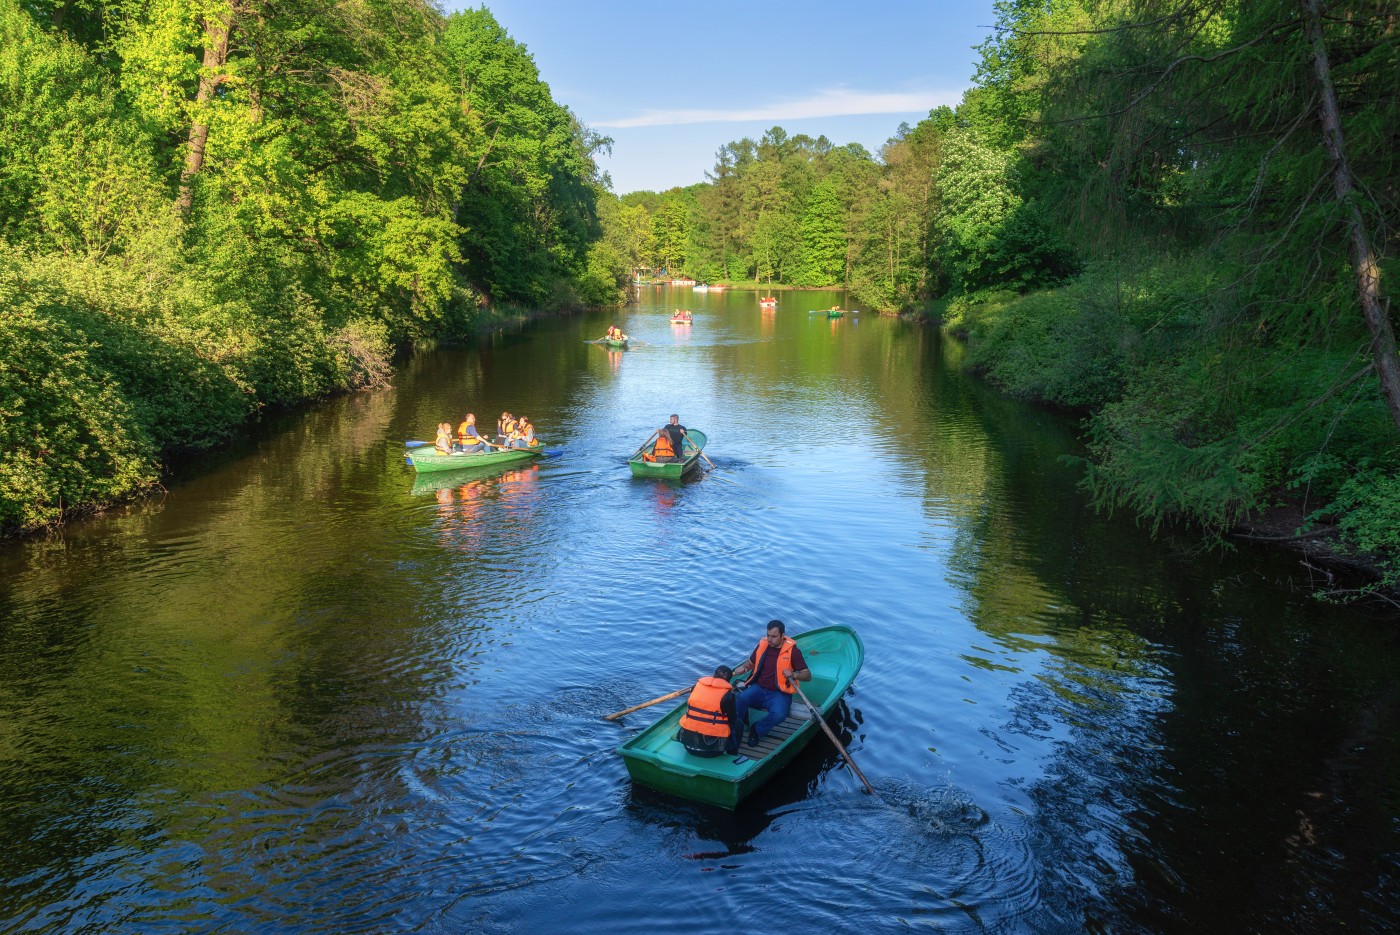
[605,0,1400,596]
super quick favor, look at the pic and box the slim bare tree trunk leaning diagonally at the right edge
[1302,0,1400,430]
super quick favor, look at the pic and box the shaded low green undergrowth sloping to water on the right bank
[944,255,1400,593]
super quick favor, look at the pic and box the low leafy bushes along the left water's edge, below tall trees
[0,251,585,537]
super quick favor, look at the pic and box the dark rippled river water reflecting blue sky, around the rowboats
[0,287,1400,932]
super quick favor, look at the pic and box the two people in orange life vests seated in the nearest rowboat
[676,620,812,757]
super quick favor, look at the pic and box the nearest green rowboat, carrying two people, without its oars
[617,626,865,809]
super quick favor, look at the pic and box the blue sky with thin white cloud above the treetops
[444,0,995,195]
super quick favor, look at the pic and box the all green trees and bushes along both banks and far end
[0,0,1400,600]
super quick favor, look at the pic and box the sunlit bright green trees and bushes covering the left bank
[0,0,620,529]
